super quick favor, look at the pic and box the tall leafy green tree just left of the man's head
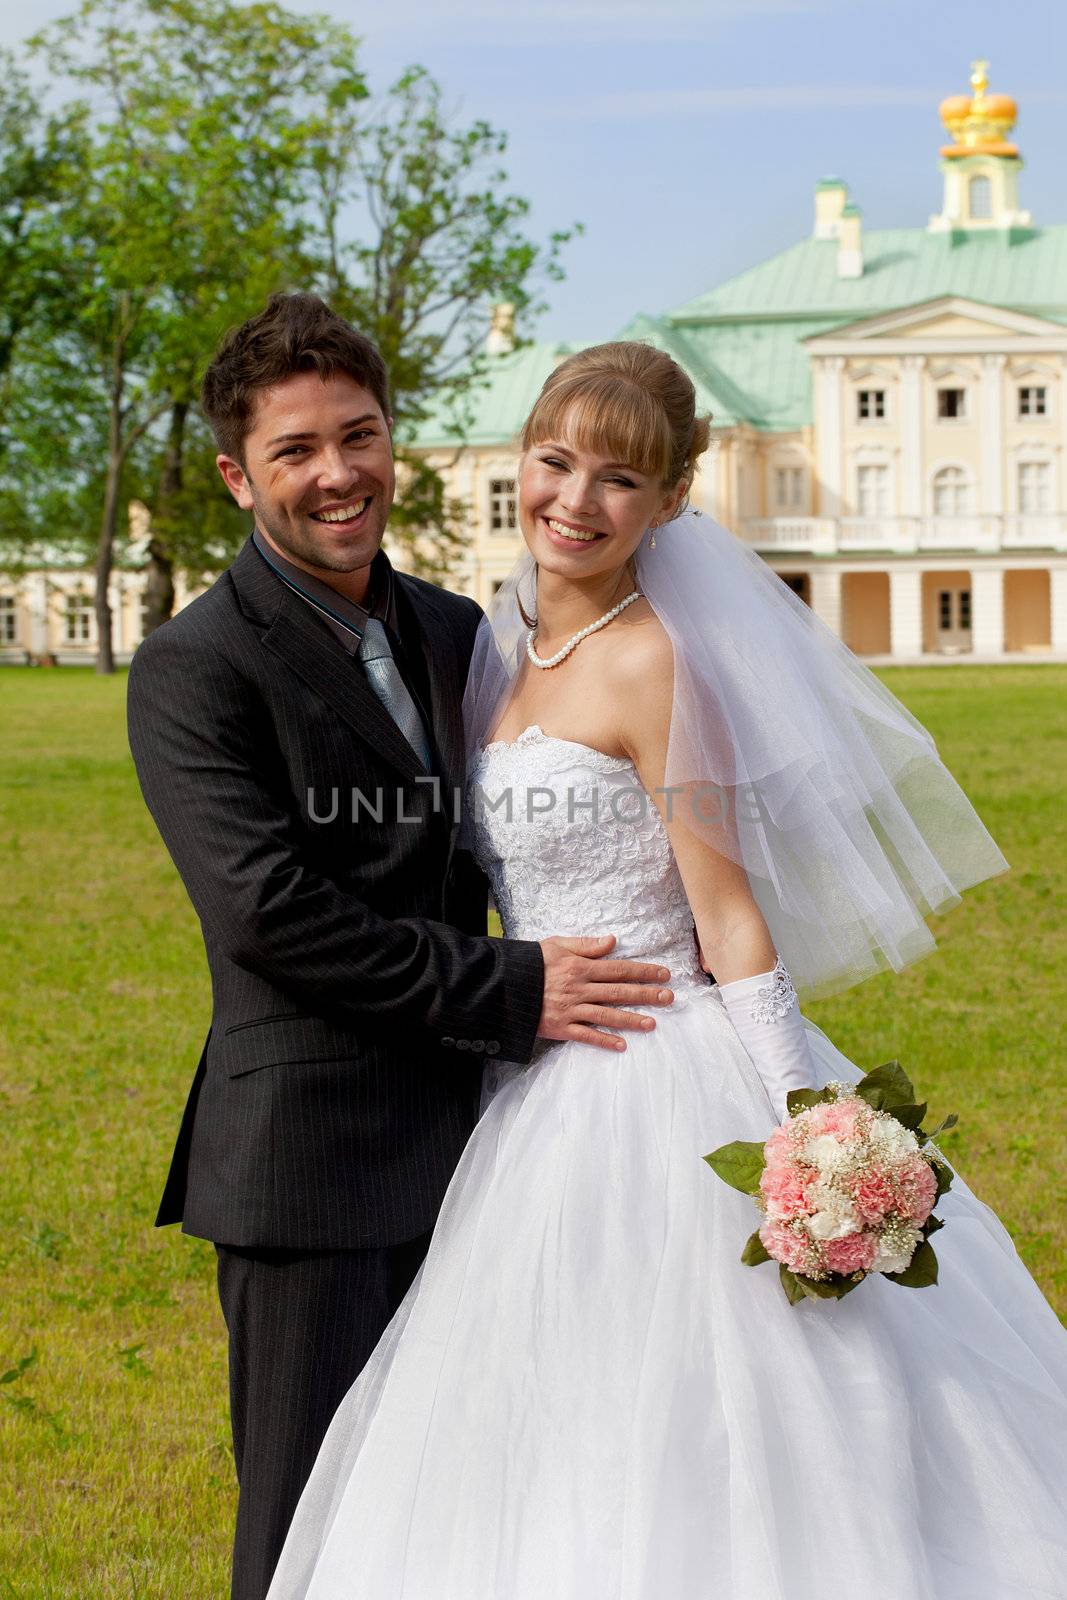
[27,0,365,672]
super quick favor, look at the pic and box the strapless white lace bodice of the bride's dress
[467,723,707,992]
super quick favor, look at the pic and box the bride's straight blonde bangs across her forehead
[525,373,670,478]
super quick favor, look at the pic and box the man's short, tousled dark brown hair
[200,294,389,462]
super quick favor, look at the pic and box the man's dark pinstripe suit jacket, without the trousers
[128,541,544,1250]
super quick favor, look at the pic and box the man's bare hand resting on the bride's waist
[537,933,673,1050]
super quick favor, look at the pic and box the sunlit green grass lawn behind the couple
[0,666,1067,1600]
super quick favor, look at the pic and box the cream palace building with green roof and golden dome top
[0,61,1067,662]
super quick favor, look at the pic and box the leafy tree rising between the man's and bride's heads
[315,67,574,578]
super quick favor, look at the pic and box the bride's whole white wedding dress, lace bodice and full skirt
[270,726,1067,1600]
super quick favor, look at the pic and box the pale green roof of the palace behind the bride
[414,220,1067,448]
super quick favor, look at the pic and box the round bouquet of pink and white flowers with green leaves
[704,1061,958,1306]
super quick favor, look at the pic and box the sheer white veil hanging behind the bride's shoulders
[464,510,1008,995]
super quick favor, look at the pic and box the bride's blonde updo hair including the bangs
[522,339,712,488]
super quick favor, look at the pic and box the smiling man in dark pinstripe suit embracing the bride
[128,294,670,1600]
